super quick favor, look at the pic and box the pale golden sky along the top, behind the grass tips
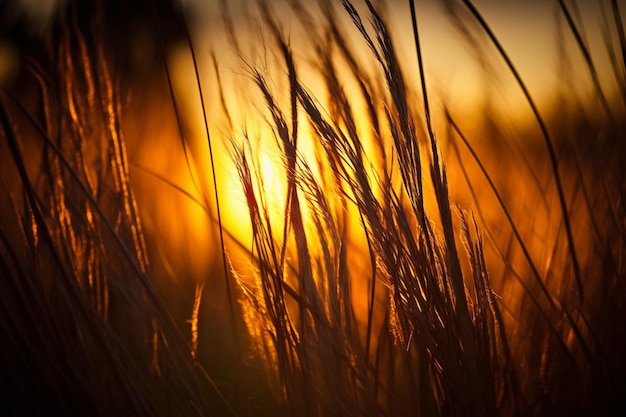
[185,0,614,128]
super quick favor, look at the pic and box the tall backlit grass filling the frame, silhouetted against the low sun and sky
[0,0,626,416]
